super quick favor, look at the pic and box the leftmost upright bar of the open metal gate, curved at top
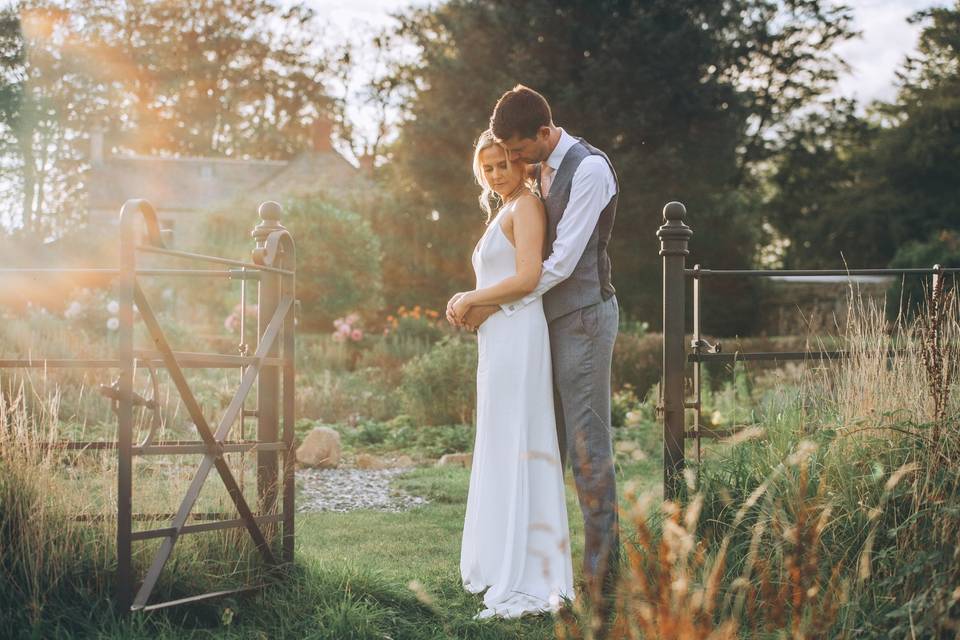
[115,205,138,613]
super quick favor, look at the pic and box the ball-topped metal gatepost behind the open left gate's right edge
[250,203,283,537]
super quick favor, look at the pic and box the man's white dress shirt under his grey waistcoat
[500,128,617,316]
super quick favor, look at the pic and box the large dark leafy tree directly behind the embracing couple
[378,0,850,331]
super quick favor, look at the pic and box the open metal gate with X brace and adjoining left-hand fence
[0,199,296,611]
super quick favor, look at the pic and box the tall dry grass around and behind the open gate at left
[0,379,270,637]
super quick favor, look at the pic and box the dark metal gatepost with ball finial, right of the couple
[657,202,693,500]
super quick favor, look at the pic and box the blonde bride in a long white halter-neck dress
[447,130,573,618]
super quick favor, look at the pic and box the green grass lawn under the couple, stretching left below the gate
[100,450,661,640]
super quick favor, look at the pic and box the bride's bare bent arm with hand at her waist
[457,195,547,317]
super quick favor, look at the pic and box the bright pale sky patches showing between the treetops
[311,0,950,102]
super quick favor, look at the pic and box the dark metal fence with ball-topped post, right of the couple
[657,202,960,499]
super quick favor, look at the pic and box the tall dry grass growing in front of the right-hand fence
[557,282,960,640]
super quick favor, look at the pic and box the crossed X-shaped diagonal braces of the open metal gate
[131,284,293,611]
